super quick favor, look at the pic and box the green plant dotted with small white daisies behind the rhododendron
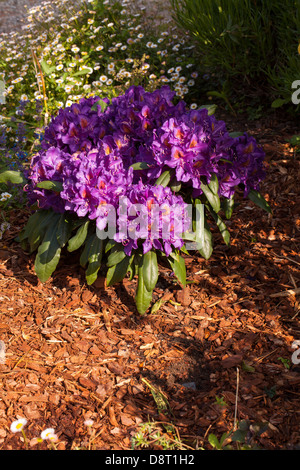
[0,0,199,162]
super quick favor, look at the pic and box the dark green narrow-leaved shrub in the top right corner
[170,0,300,111]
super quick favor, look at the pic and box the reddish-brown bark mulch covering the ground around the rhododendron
[0,111,300,450]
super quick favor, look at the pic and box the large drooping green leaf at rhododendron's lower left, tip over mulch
[34,218,61,282]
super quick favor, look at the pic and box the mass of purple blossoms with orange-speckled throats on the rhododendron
[26,86,264,253]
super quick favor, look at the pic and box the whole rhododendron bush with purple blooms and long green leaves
[14,86,270,314]
